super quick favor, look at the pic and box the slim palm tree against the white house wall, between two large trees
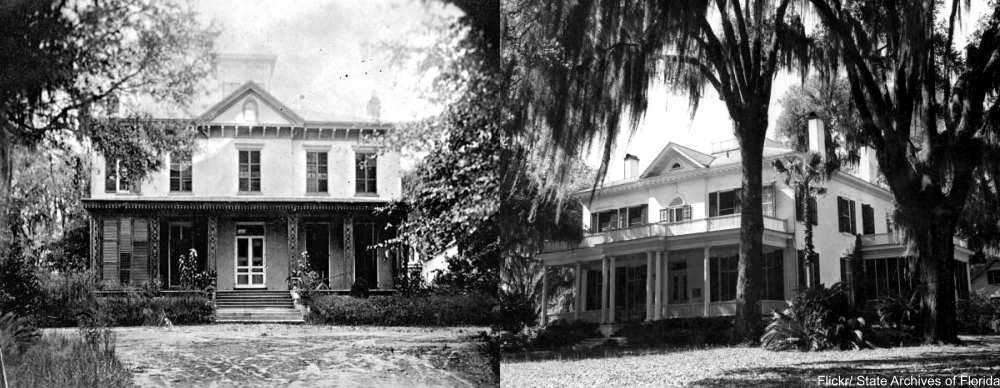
[772,152,828,287]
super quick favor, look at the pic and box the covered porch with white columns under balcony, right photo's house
[540,224,798,326]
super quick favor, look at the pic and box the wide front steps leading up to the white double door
[215,290,305,323]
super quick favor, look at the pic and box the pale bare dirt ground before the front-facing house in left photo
[52,324,495,388]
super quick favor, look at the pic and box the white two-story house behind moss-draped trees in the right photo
[539,116,972,324]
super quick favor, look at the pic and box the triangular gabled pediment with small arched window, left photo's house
[201,82,304,126]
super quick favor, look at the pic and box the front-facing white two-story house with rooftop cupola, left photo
[83,56,403,291]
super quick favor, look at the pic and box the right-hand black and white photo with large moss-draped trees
[504,0,1000,388]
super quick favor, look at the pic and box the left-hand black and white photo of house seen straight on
[0,0,505,388]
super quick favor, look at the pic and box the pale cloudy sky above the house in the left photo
[193,0,461,121]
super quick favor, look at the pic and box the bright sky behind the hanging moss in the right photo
[586,0,989,182]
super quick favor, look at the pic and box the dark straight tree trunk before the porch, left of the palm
[733,119,767,343]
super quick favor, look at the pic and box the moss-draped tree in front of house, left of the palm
[504,0,809,341]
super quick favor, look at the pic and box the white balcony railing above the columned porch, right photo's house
[544,214,787,252]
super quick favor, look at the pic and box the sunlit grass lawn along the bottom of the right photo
[500,336,1000,388]
